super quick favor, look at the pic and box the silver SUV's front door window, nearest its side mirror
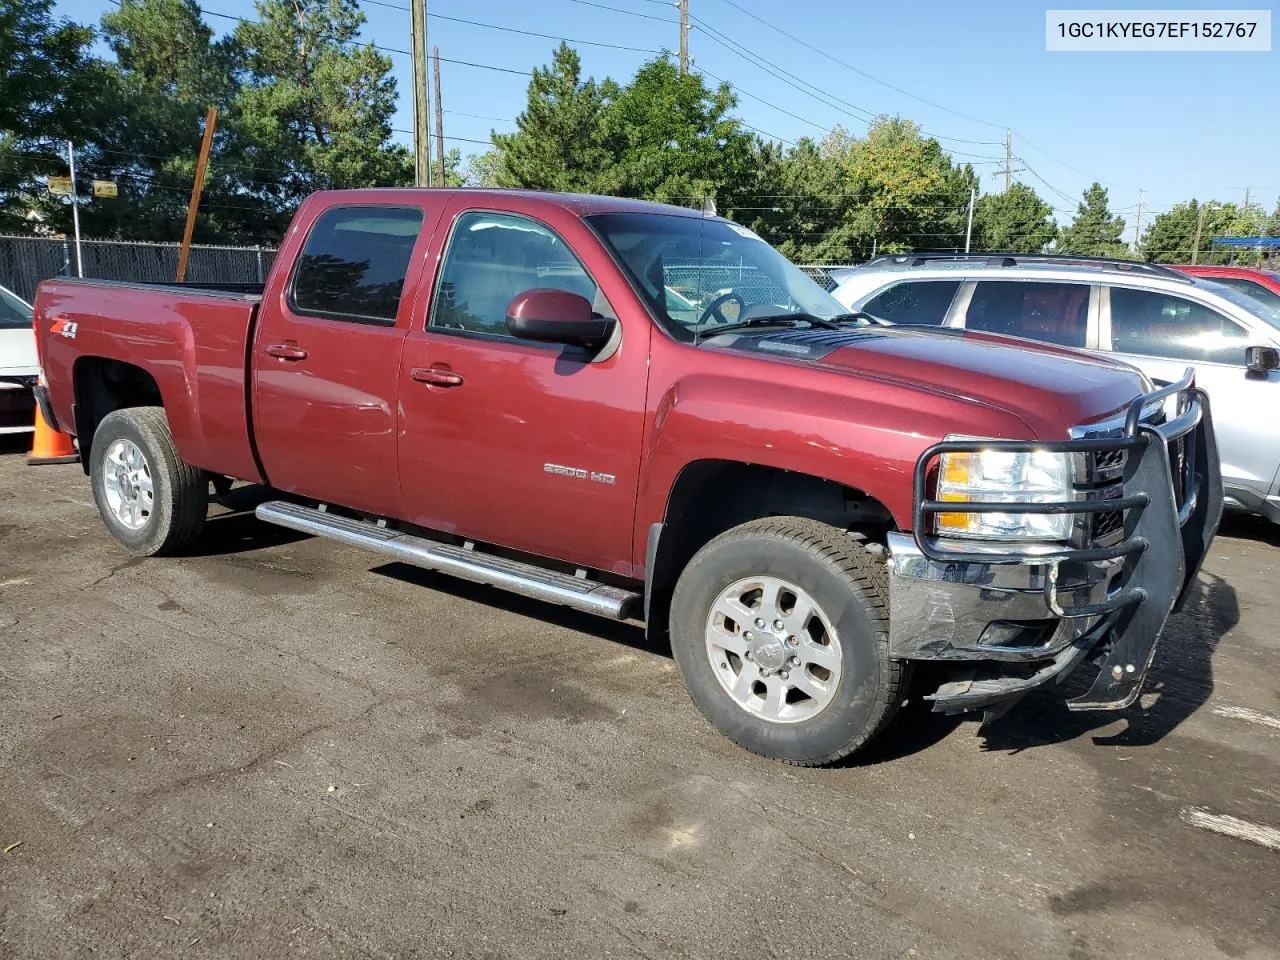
[1111,287,1247,366]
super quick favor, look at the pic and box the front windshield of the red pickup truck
[586,214,846,340]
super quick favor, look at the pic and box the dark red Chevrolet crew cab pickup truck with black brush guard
[35,189,1222,765]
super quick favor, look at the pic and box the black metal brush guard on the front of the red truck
[914,369,1222,710]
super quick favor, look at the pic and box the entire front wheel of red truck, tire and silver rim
[671,517,902,767]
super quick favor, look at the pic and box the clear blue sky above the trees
[49,0,1280,228]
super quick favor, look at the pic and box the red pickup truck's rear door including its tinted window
[252,202,431,515]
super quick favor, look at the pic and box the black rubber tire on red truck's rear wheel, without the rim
[90,407,209,557]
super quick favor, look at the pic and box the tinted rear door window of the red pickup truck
[292,206,422,326]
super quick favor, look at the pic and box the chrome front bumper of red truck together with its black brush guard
[888,370,1222,713]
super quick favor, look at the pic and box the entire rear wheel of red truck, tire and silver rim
[90,407,209,557]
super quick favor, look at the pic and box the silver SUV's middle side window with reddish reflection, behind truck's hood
[965,280,1089,347]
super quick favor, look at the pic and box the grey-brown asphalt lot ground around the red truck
[0,442,1280,960]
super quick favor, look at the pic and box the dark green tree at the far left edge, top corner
[0,0,95,232]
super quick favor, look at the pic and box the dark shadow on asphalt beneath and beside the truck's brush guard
[980,572,1240,753]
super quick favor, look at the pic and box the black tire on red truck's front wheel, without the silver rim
[671,517,904,767]
